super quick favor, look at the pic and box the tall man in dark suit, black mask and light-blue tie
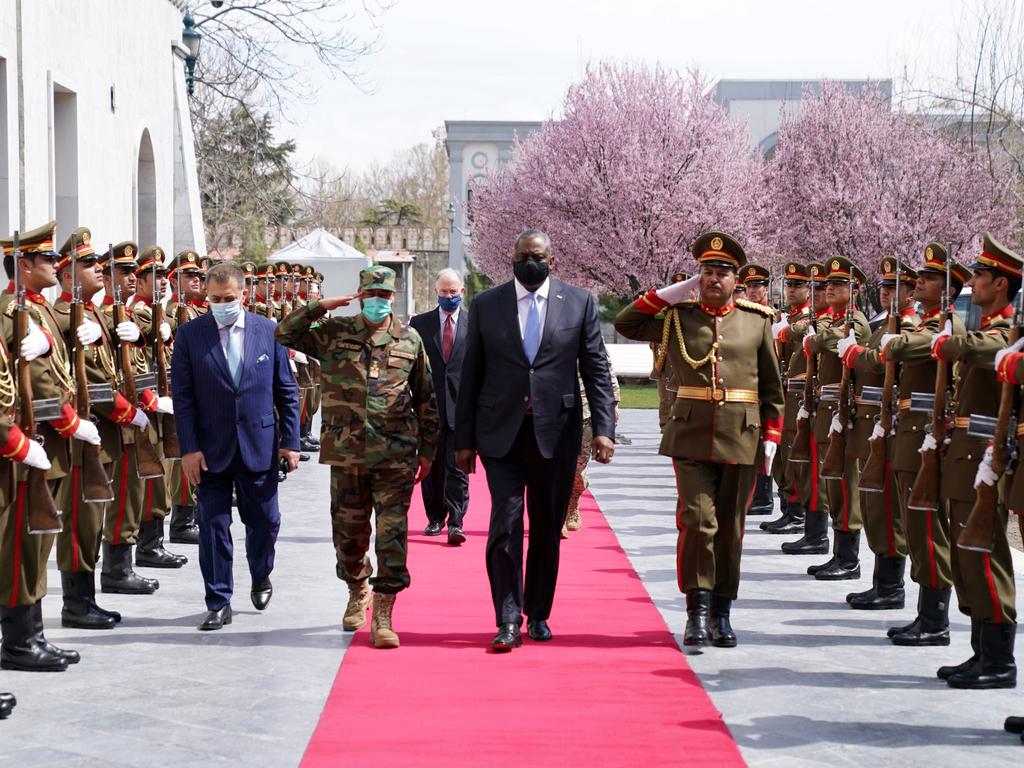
[455,229,614,652]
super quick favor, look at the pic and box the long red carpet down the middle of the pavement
[302,479,743,768]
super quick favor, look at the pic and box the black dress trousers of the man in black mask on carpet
[480,414,577,626]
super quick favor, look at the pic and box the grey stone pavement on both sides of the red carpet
[0,411,1024,768]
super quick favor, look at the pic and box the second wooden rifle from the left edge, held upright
[68,234,114,504]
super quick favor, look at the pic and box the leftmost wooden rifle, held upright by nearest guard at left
[10,231,63,535]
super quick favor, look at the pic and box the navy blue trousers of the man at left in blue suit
[197,450,281,610]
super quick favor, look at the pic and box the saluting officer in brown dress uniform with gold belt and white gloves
[615,231,784,647]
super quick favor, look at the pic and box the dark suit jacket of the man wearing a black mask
[455,278,614,459]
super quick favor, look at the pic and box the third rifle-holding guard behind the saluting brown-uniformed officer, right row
[774,262,831,555]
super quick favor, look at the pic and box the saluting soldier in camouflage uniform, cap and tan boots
[276,266,439,648]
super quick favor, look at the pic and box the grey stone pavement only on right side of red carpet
[591,411,1024,767]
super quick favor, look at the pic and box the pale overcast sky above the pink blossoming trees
[281,0,965,171]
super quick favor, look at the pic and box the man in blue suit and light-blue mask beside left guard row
[171,263,299,630]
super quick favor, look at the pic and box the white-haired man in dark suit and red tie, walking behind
[410,269,469,547]
